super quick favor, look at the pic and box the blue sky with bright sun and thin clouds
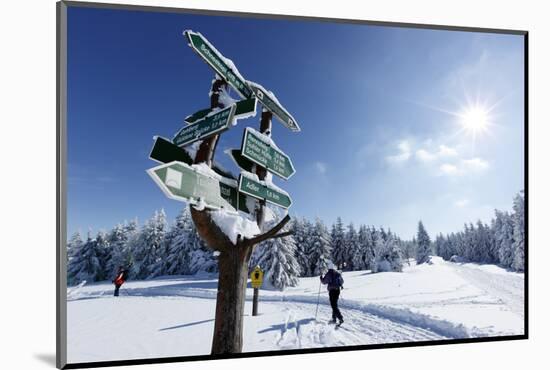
[67,7,524,239]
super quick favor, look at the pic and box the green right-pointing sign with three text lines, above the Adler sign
[241,127,296,180]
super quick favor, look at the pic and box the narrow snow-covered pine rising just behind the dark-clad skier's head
[308,218,332,276]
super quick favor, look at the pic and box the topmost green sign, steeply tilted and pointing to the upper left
[183,30,252,98]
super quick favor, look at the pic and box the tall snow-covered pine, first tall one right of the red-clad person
[131,209,167,279]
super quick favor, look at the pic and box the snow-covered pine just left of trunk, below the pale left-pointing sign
[166,207,194,275]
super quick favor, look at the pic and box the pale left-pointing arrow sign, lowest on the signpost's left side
[147,162,237,211]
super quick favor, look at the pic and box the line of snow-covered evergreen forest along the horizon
[67,192,525,289]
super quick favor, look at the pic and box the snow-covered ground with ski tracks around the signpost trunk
[67,257,524,362]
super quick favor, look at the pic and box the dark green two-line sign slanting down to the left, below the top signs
[172,104,235,146]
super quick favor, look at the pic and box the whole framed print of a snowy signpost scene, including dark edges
[57,1,528,368]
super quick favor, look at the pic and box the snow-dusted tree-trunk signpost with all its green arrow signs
[148,30,300,354]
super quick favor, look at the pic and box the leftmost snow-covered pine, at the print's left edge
[67,231,104,284]
